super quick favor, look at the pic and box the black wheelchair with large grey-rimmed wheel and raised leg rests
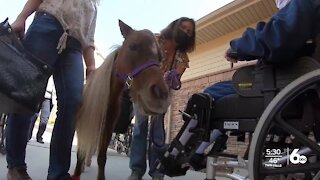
[155,57,320,180]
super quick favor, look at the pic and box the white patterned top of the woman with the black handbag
[38,0,97,53]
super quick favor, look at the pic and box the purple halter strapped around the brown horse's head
[116,60,160,89]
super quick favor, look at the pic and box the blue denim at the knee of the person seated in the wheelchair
[203,81,236,101]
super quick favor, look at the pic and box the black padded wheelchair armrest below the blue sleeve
[232,57,320,97]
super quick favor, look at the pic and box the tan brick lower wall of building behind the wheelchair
[165,69,248,157]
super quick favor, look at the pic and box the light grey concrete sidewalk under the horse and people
[0,126,205,180]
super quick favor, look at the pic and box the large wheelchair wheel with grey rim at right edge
[249,70,320,180]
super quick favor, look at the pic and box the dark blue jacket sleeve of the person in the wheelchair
[230,0,320,62]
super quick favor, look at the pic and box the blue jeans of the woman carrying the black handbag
[6,13,84,180]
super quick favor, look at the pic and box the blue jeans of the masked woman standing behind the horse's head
[129,105,165,177]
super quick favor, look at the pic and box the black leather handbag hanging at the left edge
[0,19,52,112]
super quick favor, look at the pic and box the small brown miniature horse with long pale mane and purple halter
[73,20,169,180]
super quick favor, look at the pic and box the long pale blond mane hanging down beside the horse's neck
[76,51,117,157]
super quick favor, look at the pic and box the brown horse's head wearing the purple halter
[116,20,169,114]
